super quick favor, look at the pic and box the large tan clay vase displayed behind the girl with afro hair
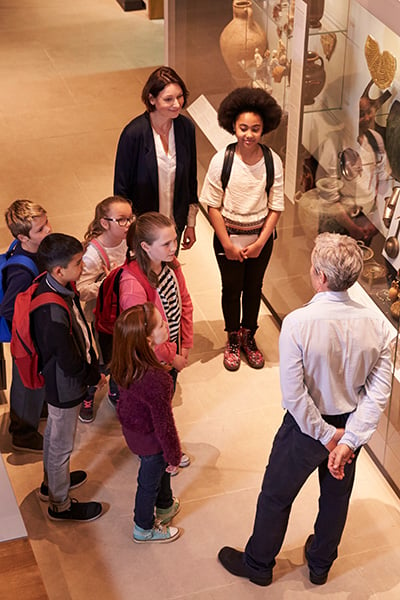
[219,0,268,86]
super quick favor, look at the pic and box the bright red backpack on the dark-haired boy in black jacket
[10,279,72,390]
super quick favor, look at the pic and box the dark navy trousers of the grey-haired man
[245,413,359,576]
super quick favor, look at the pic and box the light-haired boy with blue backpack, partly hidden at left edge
[0,200,51,453]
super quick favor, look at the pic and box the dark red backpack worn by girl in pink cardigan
[94,261,157,335]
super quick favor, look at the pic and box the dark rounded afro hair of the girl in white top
[218,87,282,134]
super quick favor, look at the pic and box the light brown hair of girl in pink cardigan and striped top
[126,211,177,287]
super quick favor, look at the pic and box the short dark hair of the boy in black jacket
[37,233,83,272]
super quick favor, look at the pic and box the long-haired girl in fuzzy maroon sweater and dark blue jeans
[111,302,181,543]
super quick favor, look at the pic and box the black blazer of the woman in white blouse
[114,112,198,231]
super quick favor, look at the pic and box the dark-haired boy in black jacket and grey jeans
[30,233,106,521]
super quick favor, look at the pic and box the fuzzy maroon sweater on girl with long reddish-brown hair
[117,369,181,466]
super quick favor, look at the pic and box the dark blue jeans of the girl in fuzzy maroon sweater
[134,452,173,529]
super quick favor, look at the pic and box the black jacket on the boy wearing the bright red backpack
[31,274,100,408]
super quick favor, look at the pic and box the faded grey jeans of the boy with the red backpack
[43,404,81,512]
